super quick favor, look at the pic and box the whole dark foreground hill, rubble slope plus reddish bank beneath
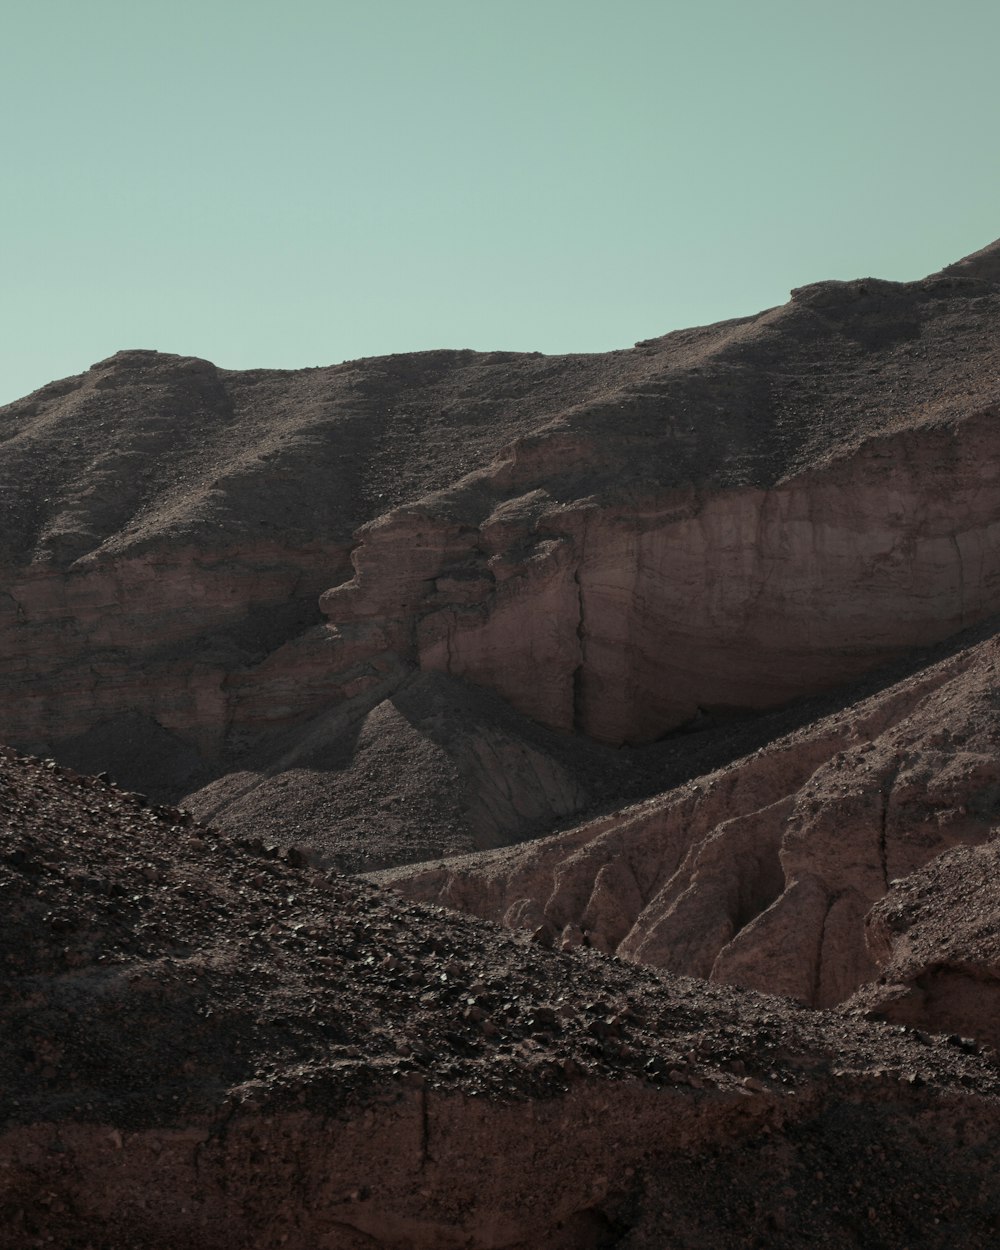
[0,750,1000,1250]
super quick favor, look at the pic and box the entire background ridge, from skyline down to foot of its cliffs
[0,245,1000,845]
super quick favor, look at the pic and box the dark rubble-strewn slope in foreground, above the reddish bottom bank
[9,749,1000,1124]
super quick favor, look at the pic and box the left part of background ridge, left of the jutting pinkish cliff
[0,351,602,796]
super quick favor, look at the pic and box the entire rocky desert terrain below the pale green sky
[0,243,1000,1250]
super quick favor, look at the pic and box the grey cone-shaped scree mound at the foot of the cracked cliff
[180,673,915,871]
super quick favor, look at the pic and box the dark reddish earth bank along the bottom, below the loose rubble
[7,1076,1000,1250]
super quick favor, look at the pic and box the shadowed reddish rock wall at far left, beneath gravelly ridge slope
[0,544,350,758]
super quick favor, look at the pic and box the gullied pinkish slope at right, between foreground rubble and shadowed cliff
[379,625,1000,1006]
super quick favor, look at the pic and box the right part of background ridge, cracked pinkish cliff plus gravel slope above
[321,258,1000,743]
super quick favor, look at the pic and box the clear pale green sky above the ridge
[0,0,1000,404]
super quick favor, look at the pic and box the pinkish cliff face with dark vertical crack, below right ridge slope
[320,408,1000,744]
